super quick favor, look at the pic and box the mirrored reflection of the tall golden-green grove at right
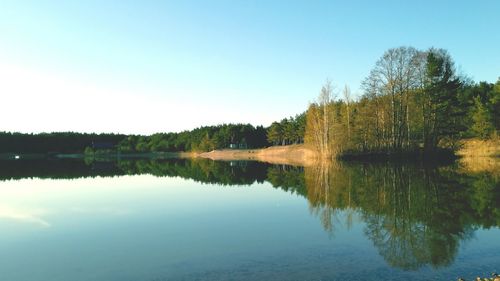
[298,163,494,270]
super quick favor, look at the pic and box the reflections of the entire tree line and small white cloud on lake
[0,159,500,270]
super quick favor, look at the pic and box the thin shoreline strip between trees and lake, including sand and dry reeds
[0,139,500,169]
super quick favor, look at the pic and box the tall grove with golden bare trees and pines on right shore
[304,44,500,157]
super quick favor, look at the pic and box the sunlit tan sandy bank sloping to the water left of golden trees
[197,144,316,166]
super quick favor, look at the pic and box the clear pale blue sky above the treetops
[0,0,500,134]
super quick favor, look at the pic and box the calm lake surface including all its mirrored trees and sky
[0,160,500,281]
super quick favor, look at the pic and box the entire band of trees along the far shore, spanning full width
[0,47,500,158]
